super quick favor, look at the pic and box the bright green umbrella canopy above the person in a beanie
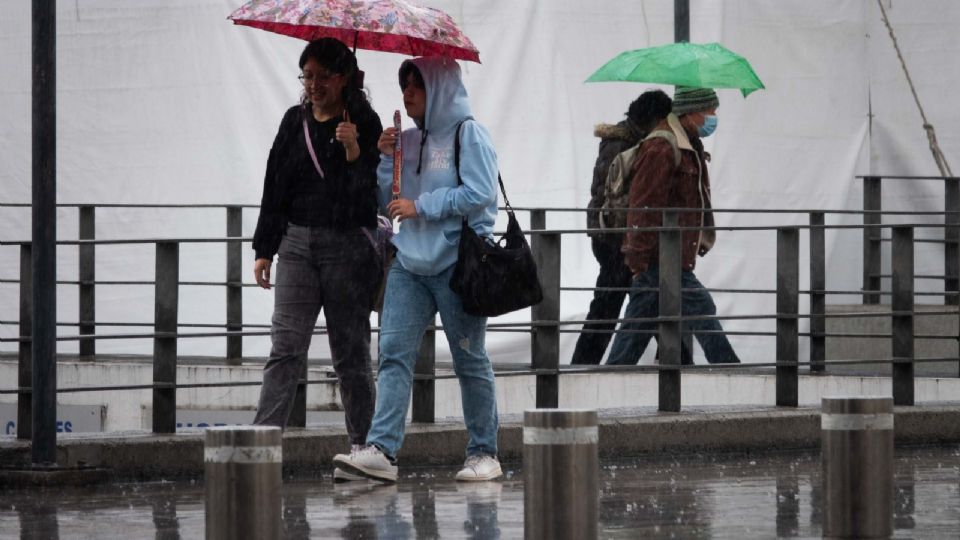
[587,42,764,97]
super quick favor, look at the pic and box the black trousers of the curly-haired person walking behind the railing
[570,238,693,365]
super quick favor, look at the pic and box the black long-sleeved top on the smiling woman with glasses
[253,105,382,259]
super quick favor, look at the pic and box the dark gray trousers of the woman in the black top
[253,224,382,444]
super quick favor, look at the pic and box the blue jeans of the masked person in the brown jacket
[607,266,740,365]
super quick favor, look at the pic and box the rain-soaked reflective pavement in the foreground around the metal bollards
[0,445,960,539]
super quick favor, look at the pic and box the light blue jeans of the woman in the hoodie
[367,261,498,457]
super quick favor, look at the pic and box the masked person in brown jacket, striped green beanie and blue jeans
[607,87,740,365]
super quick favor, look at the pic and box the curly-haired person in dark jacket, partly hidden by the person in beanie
[570,90,687,364]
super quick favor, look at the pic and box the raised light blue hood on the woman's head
[404,56,473,135]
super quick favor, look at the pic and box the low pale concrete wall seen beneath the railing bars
[0,361,960,431]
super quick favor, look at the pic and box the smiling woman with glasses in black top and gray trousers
[253,38,382,479]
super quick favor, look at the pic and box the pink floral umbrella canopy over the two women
[228,0,480,63]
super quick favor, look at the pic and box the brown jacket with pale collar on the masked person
[621,114,716,275]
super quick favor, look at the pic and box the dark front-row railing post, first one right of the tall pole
[153,242,180,433]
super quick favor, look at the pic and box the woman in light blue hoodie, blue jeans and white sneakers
[334,57,502,482]
